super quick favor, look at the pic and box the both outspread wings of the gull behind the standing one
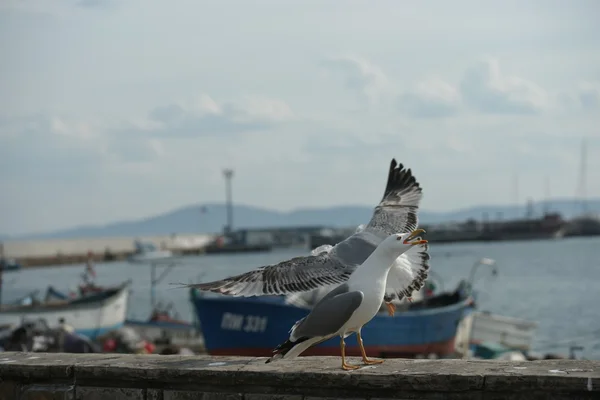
[177,159,421,296]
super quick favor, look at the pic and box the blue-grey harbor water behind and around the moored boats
[2,237,600,359]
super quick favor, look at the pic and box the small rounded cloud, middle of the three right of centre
[398,78,461,118]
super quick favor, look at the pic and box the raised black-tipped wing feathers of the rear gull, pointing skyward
[365,159,422,236]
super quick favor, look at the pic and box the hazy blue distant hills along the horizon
[5,199,600,240]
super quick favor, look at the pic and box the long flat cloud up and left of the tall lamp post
[139,95,294,137]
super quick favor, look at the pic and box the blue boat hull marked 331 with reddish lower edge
[191,289,472,358]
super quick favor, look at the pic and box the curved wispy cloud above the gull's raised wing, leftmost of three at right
[323,56,390,105]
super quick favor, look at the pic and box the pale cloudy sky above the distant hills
[0,0,600,235]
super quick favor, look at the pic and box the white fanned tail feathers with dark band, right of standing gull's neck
[384,244,429,302]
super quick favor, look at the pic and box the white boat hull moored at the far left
[0,282,129,339]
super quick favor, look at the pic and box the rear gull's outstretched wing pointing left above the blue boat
[184,251,353,296]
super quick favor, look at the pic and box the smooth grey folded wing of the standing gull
[290,285,364,342]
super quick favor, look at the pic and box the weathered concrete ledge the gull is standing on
[0,353,600,400]
